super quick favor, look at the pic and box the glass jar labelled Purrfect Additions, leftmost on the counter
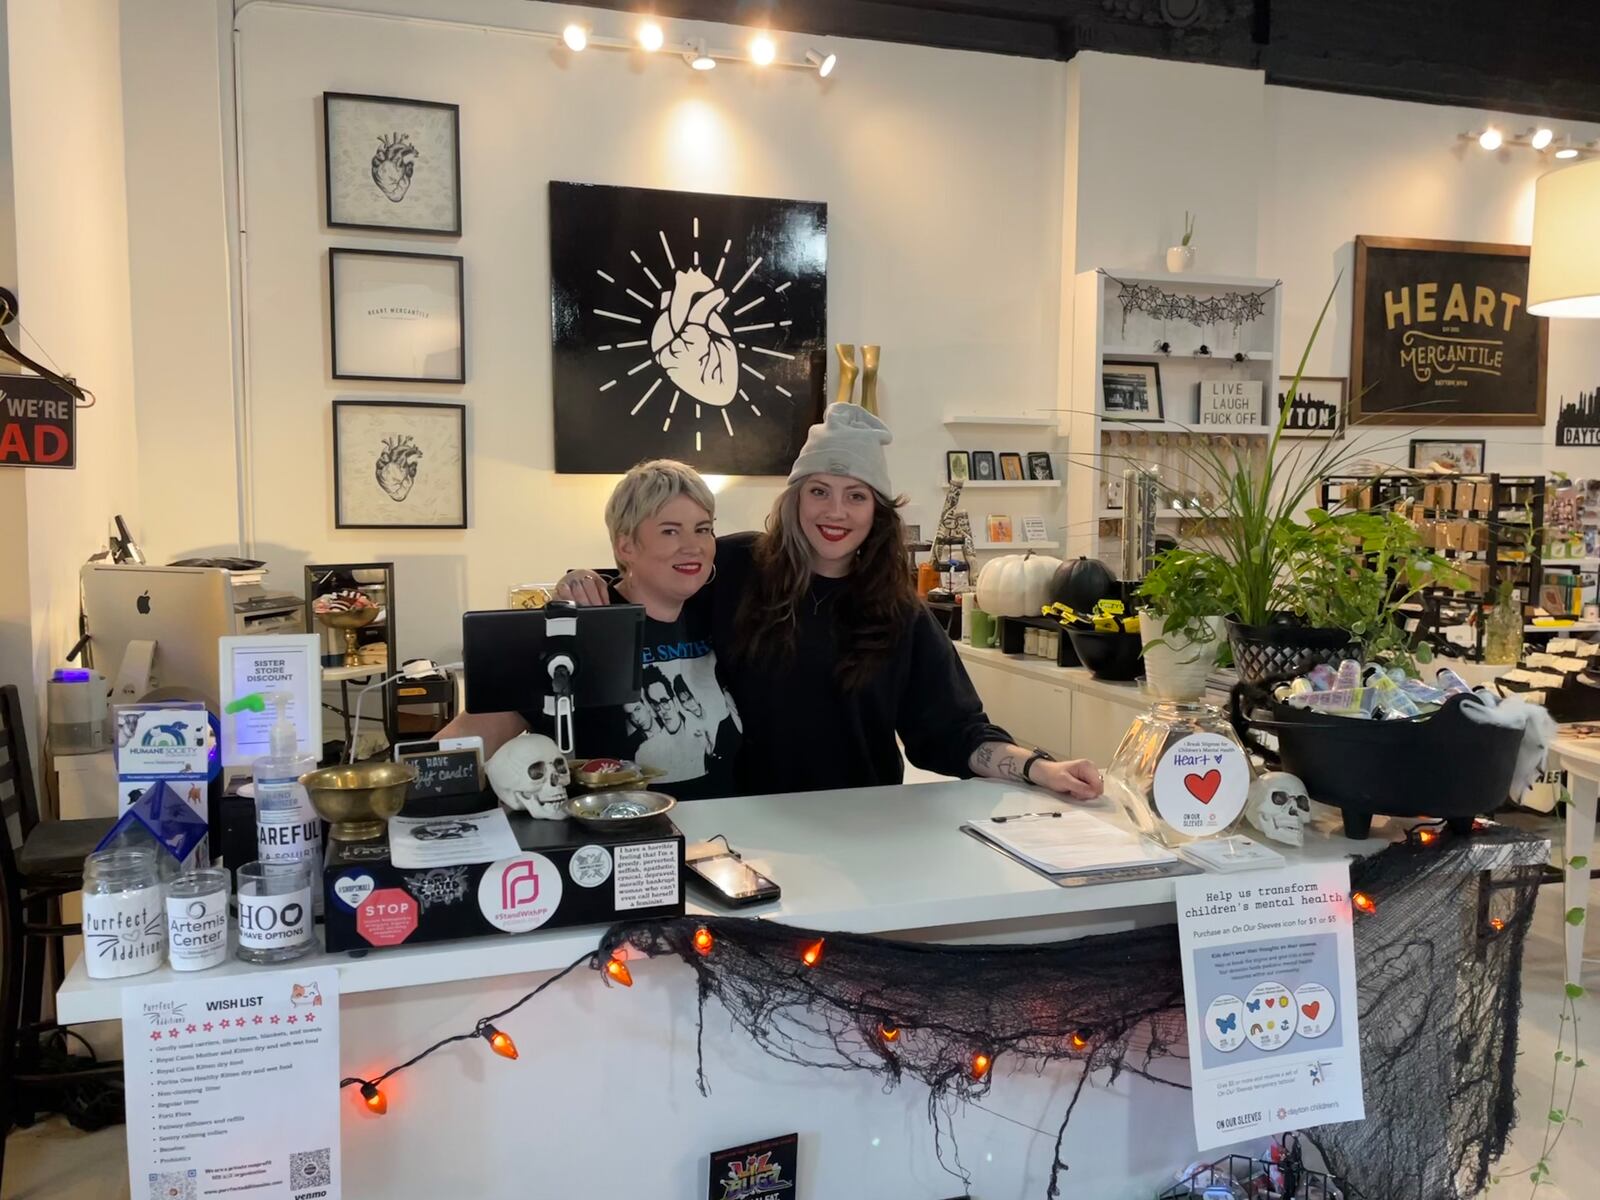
[83,850,166,979]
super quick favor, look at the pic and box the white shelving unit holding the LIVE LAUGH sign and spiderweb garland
[1064,267,1283,562]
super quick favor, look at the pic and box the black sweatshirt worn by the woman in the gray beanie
[712,533,1011,795]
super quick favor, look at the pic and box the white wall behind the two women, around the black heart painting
[240,3,1064,654]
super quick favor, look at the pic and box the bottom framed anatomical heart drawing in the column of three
[333,400,469,530]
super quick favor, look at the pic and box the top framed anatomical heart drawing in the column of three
[322,91,461,237]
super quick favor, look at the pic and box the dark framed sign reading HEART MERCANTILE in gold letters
[1350,237,1550,426]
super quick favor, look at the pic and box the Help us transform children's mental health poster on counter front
[1174,862,1366,1150]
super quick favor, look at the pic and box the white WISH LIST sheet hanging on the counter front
[122,966,341,1200]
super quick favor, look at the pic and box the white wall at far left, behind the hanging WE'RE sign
[6,0,139,723]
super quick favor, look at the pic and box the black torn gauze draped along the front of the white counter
[597,826,1547,1200]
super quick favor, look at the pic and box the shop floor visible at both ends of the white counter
[3,886,1600,1200]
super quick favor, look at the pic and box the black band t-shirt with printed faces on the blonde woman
[534,587,742,800]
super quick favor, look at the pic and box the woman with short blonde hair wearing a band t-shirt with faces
[438,459,741,800]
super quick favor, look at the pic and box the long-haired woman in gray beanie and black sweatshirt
[560,405,1101,809]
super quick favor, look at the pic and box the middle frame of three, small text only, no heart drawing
[328,246,467,384]
